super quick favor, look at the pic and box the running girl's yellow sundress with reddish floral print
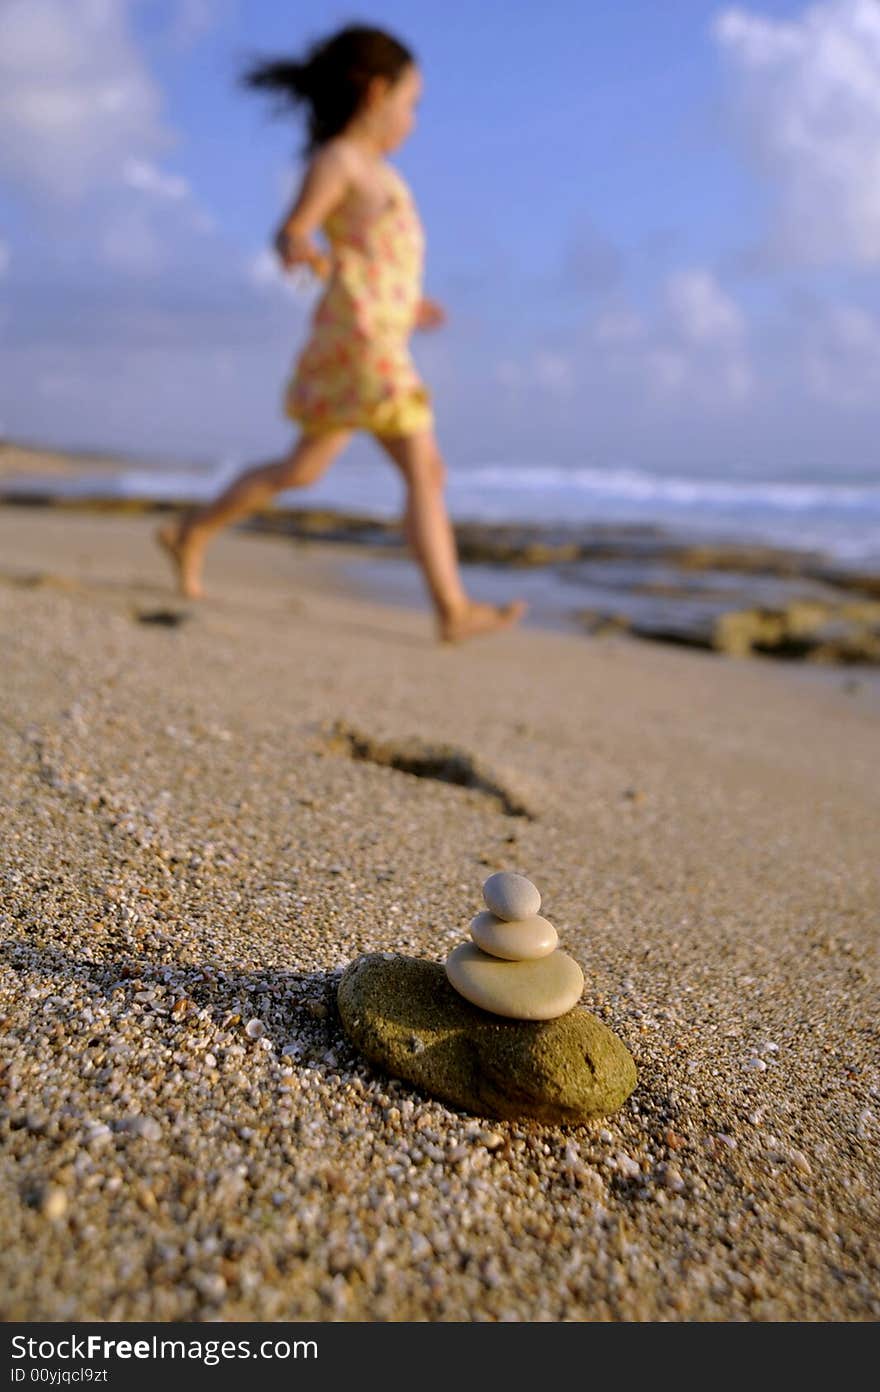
[285,164,433,436]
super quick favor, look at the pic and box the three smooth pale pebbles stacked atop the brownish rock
[446,870,583,1020]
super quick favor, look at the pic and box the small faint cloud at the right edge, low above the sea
[803,305,880,408]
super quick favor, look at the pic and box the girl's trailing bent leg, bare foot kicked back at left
[156,430,351,599]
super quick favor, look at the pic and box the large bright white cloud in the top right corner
[713,0,880,264]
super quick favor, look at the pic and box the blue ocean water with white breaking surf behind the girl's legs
[44,455,880,569]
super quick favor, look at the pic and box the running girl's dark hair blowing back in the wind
[242,24,415,153]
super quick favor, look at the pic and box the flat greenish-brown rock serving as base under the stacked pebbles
[337,954,636,1125]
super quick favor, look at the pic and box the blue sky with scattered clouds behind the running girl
[0,0,880,477]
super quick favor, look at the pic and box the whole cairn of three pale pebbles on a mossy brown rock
[337,871,636,1125]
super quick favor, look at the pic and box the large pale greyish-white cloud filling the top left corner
[0,0,170,200]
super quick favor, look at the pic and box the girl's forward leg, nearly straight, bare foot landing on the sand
[377,432,526,642]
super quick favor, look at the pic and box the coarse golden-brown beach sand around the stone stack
[0,508,880,1321]
